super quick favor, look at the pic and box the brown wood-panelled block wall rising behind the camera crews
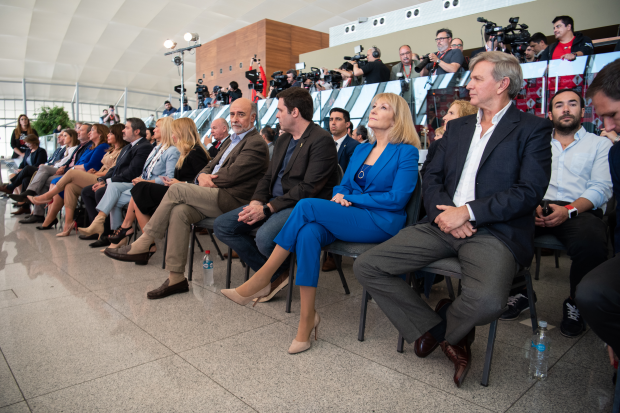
[196,19,329,107]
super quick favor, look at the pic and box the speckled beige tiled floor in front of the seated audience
[0,200,613,413]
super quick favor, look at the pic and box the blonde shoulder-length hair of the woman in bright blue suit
[368,93,420,149]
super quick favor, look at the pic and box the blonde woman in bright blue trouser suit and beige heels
[222,93,420,354]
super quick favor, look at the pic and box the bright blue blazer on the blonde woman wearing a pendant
[334,143,419,235]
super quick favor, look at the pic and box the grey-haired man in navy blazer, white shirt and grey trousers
[353,52,552,387]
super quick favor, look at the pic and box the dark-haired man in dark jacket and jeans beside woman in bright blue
[214,88,338,302]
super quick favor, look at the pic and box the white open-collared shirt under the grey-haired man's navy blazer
[452,101,512,221]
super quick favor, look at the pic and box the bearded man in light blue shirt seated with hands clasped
[500,89,612,338]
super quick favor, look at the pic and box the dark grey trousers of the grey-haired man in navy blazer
[353,223,518,344]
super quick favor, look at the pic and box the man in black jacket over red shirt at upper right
[540,16,594,61]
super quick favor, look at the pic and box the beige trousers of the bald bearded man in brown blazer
[144,183,223,273]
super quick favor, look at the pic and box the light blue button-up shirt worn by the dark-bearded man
[544,126,612,213]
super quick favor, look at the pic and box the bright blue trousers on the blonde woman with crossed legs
[274,198,392,287]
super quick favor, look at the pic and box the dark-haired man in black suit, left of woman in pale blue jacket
[80,118,153,248]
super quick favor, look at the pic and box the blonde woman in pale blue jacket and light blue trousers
[78,117,181,243]
